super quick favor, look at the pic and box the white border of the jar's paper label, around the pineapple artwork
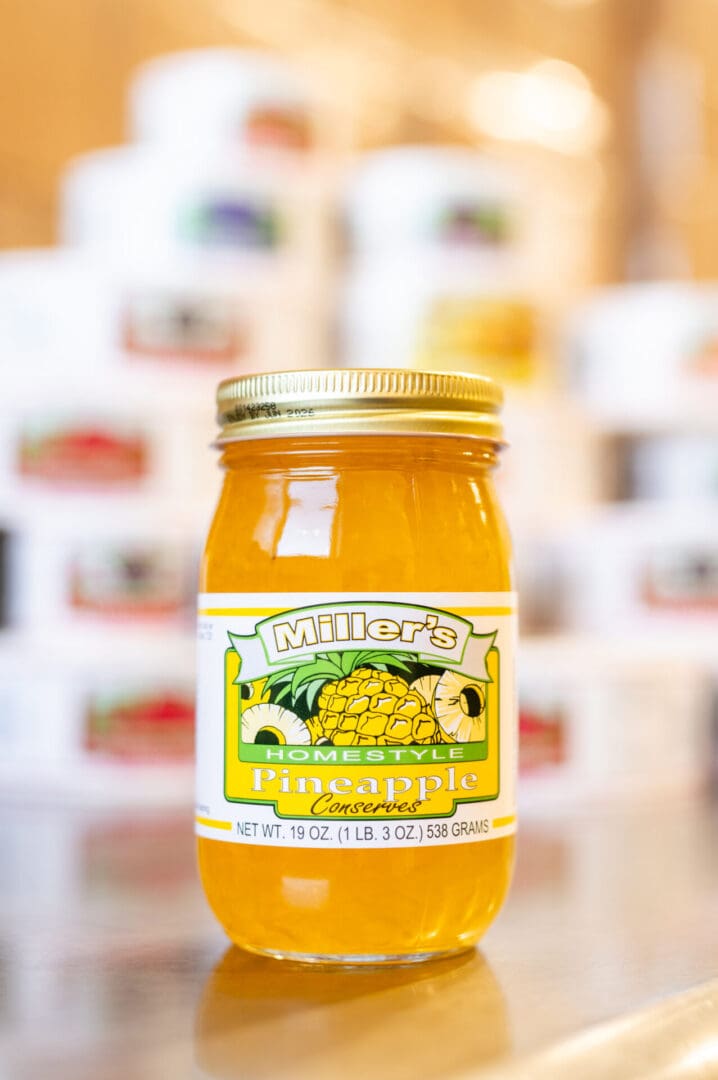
[195,593,517,848]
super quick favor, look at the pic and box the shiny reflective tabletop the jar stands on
[0,799,718,1080]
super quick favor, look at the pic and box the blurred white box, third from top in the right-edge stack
[557,503,718,639]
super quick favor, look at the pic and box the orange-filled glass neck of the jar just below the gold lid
[220,434,501,472]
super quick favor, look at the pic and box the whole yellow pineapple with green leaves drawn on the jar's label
[265,650,441,746]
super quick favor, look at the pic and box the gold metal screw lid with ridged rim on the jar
[217,368,503,446]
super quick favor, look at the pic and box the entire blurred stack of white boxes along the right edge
[521,282,718,806]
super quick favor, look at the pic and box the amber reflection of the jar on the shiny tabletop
[194,947,511,1080]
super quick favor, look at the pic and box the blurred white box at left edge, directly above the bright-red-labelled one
[0,248,327,380]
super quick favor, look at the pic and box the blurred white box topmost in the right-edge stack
[568,282,718,428]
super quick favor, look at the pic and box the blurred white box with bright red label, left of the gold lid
[0,357,229,527]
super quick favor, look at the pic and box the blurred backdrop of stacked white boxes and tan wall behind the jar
[0,0,718,851]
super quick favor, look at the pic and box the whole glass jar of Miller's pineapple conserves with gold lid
[197,369,516,963]
